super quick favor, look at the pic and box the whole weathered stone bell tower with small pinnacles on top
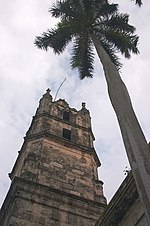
[0,89,106,226]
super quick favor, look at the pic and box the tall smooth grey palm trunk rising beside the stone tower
[91,34,150,225]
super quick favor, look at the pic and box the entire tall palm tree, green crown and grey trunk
[35,0,150,222]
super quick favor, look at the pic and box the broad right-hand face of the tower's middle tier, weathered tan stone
[38,139,105,202]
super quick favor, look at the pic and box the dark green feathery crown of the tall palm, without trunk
[35,0,138,79]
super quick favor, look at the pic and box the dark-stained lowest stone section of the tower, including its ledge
[0,178,105,226]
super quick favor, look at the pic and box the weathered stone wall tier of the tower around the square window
[28,113,93,148]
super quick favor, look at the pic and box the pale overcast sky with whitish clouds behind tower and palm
[0,0,150,208]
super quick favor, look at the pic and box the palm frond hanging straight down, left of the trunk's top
[71,33,94,79]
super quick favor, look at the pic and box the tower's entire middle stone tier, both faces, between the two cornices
[11,138,106,204]
